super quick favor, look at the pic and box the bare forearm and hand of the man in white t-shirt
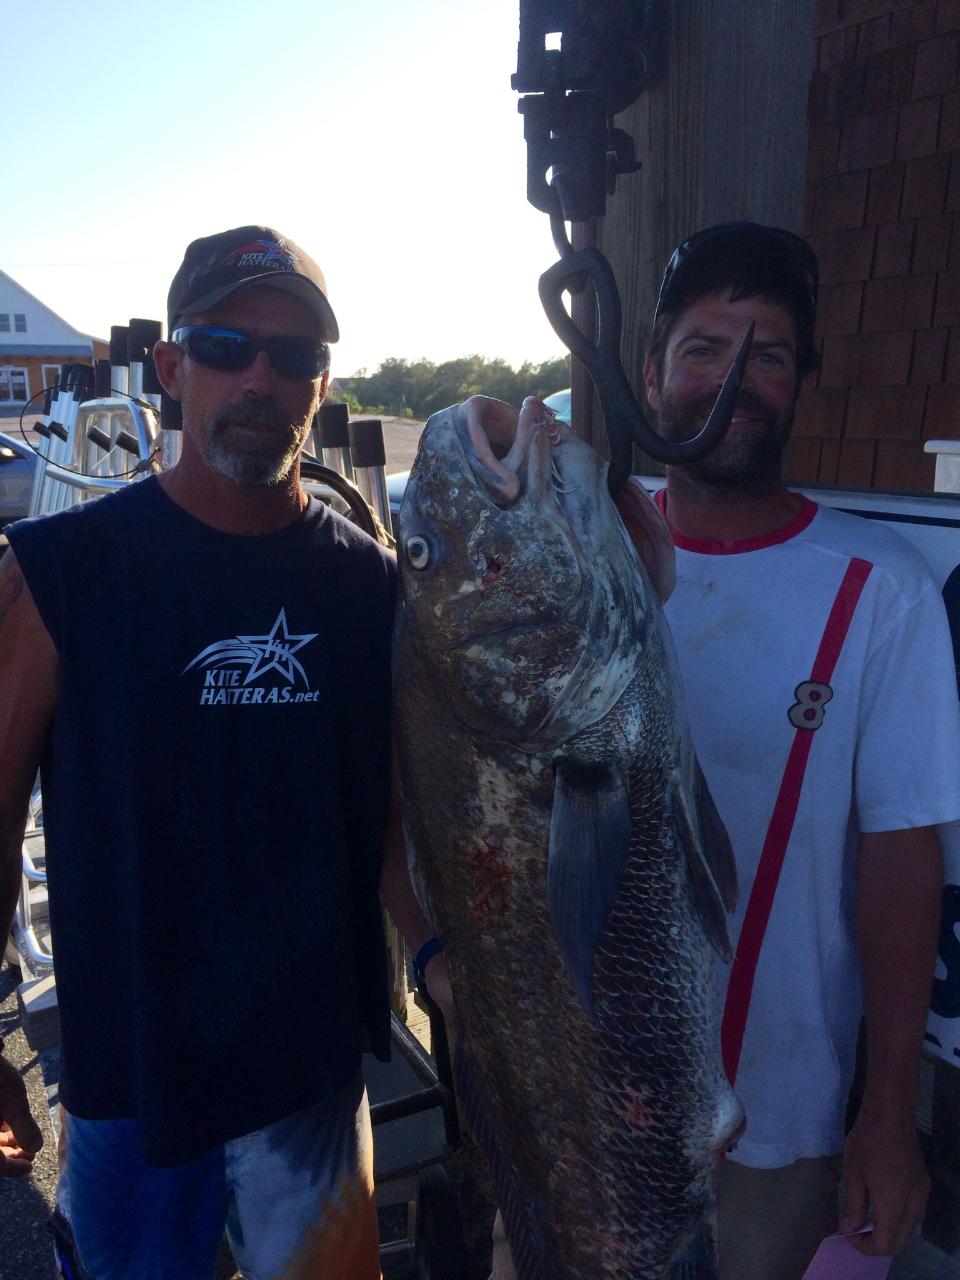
[842,827,943,1254]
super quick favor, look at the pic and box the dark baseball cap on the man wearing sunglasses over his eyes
[166,227,340,342]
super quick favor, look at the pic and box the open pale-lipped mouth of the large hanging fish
[461,396,572,508]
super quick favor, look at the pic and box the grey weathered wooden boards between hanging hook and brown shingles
[594,0,814,472]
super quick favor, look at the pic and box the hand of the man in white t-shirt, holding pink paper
[840,1108,931,1257]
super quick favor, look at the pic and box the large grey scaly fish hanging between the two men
[394,397,742,1280]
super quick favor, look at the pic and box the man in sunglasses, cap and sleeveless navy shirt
[0,227,445,1280]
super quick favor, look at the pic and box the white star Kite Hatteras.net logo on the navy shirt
[180,609,319,707]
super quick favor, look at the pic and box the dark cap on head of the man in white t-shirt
[654,223,819,323]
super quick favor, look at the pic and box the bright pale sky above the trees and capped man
[0,0,564,376]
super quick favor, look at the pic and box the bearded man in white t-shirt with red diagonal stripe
[620,223,960,1280]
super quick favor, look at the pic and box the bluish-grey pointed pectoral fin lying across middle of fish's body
[547,760,631,1019]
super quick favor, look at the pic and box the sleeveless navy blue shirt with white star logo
[6,477,396,1165]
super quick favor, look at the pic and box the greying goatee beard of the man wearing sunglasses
[204,396,307,485]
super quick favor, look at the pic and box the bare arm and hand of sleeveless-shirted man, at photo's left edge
[0,550,59,1178]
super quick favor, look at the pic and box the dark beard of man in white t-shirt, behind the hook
[658,390,794,494]
